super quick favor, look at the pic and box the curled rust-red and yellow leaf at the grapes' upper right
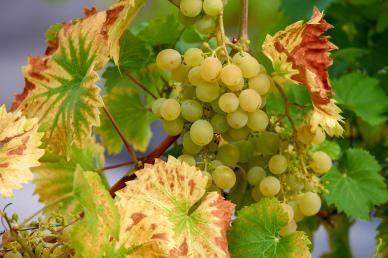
[262,8,343,135]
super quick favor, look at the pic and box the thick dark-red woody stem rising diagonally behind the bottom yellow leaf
[109,135,179,197]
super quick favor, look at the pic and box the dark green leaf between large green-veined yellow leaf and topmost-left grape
[119,30,153,70]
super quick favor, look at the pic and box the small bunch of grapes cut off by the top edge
[179,0,224,34]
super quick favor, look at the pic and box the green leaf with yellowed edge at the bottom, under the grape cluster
[228,198,311,258]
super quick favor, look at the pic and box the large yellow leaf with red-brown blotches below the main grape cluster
[116,157,234,258]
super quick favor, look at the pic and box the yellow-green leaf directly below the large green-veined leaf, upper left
[34,142,104,215]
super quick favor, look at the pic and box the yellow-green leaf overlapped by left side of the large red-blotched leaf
[70,168,120,258]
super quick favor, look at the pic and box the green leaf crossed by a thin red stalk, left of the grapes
[97,88,154,153]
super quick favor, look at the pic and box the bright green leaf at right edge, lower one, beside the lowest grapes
[322,149,388,220]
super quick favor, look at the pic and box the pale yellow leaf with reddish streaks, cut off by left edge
[0,105,44,197]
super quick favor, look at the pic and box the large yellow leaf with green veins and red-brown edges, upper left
[12,0,146,154]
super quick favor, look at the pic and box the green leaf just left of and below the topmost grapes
[138,15,183,46]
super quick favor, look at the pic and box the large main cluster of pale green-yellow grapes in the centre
[152,44,331,230]
